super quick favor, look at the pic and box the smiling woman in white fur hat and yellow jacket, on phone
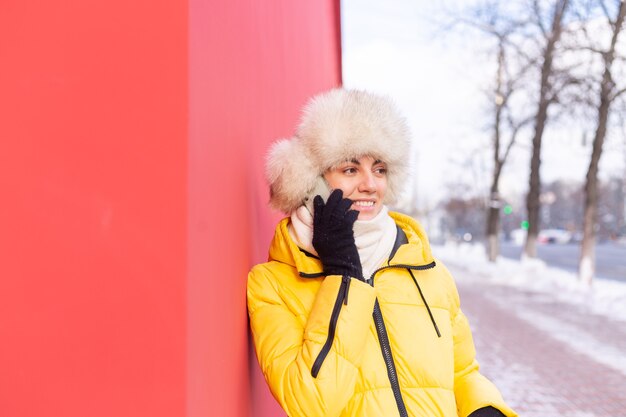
[248,89,516,417]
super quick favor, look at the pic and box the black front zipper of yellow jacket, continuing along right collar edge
[368,261,435,417]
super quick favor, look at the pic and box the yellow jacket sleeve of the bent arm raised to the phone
[248,266,376,417]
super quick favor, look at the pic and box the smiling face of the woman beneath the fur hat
[324,156,387,220]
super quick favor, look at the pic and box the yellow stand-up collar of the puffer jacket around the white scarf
[269,211,433,278]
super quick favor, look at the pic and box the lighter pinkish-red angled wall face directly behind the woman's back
[188,0,341,417]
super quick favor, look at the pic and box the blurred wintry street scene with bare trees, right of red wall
[342,4,626,417]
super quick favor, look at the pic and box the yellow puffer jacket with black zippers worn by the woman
[248,213,516,417]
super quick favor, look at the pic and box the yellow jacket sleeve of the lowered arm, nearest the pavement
[440,264,517,417]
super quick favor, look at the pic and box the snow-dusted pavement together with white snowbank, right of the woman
[433,244,626,417]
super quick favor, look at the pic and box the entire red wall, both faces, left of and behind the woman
[0,0,340,417]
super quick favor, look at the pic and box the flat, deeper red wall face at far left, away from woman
[0,0,187,417]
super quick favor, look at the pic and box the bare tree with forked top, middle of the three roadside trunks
[523,0,570,258]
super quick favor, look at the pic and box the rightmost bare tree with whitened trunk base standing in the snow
[578,0,626,285]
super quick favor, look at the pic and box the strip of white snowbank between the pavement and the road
[433,243,626,322]
